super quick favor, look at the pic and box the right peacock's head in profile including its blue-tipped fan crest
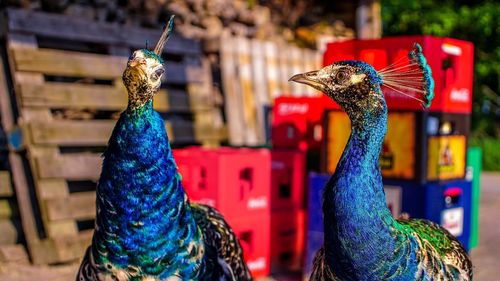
[290,44,434,124]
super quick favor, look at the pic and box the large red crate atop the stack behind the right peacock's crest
[323,36,474,113]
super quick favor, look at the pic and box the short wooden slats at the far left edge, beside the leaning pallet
[0,171,28,263]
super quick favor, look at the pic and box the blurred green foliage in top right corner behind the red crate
[381,0,500,136]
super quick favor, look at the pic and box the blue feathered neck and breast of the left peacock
[92,101,203,280]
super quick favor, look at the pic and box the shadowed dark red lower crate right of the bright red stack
[271,208,306,272]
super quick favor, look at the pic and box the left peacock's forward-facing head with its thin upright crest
[122,16,174,109]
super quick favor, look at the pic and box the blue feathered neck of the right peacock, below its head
[323,101,400,280]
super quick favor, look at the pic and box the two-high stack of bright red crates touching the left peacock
[174,147,271,277]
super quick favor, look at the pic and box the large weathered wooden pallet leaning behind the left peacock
[0,7,223,263]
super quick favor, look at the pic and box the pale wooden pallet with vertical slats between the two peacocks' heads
[220,33,322,146]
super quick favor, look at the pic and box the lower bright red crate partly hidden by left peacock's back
[227,214,271,278]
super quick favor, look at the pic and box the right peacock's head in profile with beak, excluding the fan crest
[290,60,386,120]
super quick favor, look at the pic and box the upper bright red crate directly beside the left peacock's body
[174,147,271,218]
